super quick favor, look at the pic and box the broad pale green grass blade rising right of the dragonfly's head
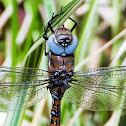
[75,0,97,64]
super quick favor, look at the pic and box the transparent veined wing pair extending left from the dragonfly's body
[0,67,49,111]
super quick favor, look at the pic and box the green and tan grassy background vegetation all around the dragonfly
[0,0,126,126]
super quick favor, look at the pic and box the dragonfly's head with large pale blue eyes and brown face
[48,27,78,55]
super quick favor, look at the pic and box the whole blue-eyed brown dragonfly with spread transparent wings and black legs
[0,10,126,126]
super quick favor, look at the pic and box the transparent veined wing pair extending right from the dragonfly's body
[64,66,126,111]
